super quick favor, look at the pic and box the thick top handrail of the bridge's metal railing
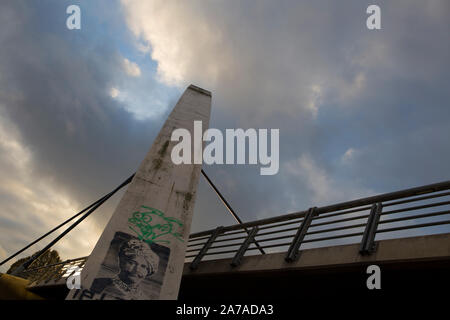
[189,181,450,238]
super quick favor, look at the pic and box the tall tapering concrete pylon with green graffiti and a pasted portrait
[67,85,211,300]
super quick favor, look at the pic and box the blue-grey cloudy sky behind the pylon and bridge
[0,0,450,271]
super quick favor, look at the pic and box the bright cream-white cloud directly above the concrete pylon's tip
[122,0,229,85]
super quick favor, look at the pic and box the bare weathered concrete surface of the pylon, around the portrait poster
[68,85,211,299]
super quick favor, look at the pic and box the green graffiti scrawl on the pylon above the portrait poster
[128,206,184,244]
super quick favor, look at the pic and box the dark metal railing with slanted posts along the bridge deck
[186,181,450,269]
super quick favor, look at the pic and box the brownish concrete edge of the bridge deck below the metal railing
[183,233,450,276]
